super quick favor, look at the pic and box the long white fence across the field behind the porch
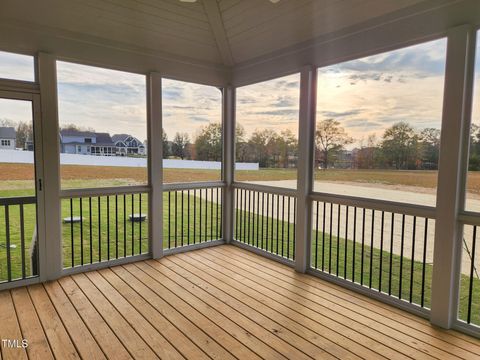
[0,150,258,170]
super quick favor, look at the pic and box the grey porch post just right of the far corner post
[295,66,317,273]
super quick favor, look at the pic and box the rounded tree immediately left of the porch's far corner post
[195,123,222,161]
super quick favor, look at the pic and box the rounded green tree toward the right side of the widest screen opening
[381,121,421,170]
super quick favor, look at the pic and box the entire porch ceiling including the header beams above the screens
[0,0,480,86]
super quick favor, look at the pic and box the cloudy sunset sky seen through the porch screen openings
[0,33,480,146]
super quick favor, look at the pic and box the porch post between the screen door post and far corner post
[147,73,163,259]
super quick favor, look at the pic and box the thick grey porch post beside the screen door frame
[37,53,63,281]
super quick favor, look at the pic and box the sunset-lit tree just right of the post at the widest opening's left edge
[315,119,353,169]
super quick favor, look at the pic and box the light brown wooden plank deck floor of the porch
[0,245,480,360]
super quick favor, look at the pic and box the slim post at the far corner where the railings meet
[222,85,235,244]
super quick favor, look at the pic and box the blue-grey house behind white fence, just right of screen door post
[60,129,116,156]
